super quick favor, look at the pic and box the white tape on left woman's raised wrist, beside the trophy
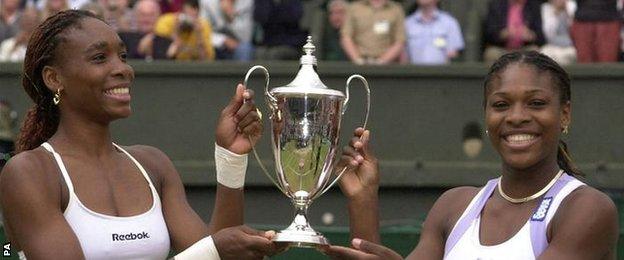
[215,143,247,189]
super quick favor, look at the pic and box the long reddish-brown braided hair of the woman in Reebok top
[16,10,99,153]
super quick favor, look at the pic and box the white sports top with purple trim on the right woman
[444,174,585,260]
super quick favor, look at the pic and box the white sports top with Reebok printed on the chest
[42,142,170,260]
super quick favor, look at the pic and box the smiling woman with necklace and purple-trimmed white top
[326,51,618,260]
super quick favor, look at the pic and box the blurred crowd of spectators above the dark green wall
[0,0,624,65]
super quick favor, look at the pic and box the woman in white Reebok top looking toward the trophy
[0,10,276,259]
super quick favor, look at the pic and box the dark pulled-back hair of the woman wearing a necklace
[483,51,584,176]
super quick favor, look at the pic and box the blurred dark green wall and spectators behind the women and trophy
[0,0,624,259]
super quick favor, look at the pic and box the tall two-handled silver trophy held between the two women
[244,36,370,247]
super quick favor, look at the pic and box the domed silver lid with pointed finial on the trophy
[270,36,345,98]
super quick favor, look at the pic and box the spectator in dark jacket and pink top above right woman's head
[484,0,545,63]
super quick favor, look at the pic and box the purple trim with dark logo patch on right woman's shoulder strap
[529,173,574,259]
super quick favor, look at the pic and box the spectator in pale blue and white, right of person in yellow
[204,0,254,61]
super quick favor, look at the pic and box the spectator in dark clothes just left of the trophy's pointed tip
[254,0,307,60]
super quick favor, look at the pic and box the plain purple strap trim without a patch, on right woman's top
[444,178,499,257]
